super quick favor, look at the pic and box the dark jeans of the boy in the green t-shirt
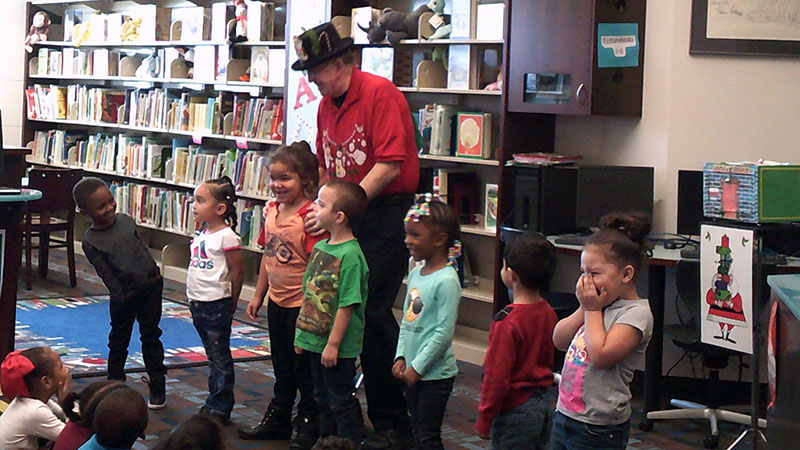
[306,351,361,447]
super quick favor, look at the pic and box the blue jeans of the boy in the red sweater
[492,388,555,450]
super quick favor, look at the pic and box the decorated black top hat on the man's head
[292,22,353,70]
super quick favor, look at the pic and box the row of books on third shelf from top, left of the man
[25,84,284,140]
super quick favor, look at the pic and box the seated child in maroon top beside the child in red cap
[52,380,125,450]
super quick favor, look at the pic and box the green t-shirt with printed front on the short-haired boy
[294,239,369,358]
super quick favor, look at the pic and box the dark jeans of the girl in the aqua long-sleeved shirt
[406,377,455,450]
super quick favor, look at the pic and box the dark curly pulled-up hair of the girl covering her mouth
[586,212,652,274]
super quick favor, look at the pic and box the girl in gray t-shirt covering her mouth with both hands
[551,214,653,450]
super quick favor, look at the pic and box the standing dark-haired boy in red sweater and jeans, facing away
[475,233,558,449]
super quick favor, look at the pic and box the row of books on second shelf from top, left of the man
[37,45,286,86]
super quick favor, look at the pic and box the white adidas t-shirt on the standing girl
[186,227,242,302]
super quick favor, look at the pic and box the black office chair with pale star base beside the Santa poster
[639,261,767,448]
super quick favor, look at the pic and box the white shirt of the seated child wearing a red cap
[0,397,66,450]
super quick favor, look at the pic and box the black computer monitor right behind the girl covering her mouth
[575,166,655,230]
